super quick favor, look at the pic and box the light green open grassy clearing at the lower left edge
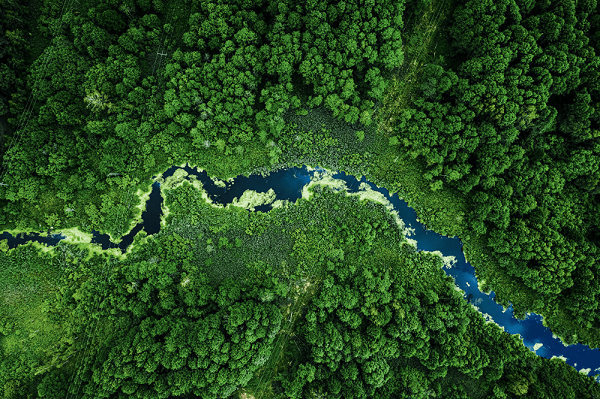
[0,242,121,396]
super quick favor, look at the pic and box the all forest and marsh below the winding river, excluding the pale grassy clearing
[0,182,600,398]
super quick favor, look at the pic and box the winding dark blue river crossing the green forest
[0,165,600,383]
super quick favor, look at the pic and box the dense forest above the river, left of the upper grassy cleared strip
[0,0,403,234]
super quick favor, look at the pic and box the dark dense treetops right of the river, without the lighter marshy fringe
[386,0,600,347]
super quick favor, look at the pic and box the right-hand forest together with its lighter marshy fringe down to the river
[282,1,600,354]
